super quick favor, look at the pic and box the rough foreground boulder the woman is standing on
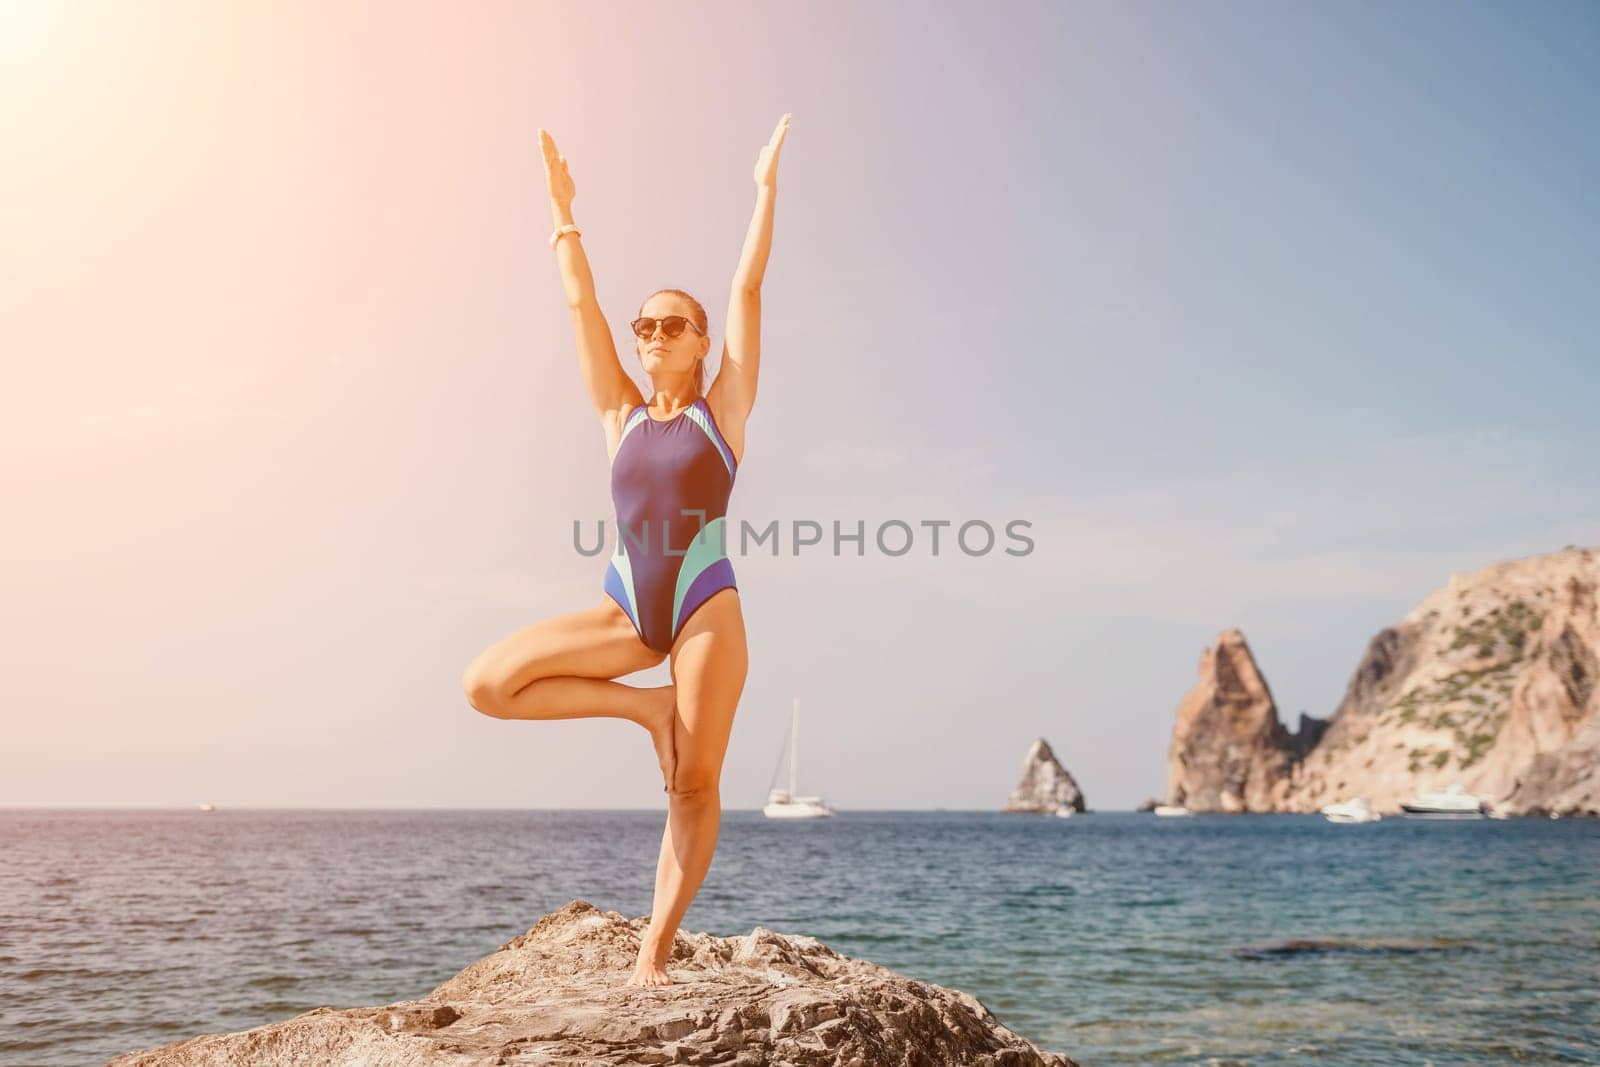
[107,901,1075,1067]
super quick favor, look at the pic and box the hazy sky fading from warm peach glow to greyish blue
[0,0,1600,811]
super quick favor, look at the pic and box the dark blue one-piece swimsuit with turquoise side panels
[605,397,738,653]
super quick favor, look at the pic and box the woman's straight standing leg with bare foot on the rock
[630,589,749,985]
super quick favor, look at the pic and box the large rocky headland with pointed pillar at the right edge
[1168,547,1600,814]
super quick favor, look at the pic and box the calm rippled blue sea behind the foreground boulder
[0,809,1600,1067]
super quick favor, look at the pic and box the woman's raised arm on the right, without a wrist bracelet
[706,115,789,435]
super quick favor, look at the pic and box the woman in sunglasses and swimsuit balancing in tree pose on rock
[462,115,789,985]
